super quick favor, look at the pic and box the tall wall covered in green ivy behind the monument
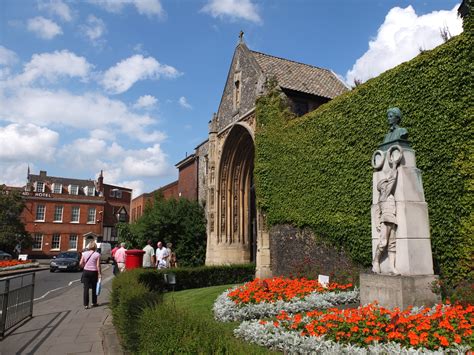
[255,34,474,282]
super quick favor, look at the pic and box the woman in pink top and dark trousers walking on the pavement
[80,241,102,309]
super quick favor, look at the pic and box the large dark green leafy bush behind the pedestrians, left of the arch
[130,195,206,266]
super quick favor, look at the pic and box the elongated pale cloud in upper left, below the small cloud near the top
[14,50,92,84]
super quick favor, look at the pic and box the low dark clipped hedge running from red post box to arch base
[140,264,255,291]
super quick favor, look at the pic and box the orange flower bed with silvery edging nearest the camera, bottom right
[235,304,474,353]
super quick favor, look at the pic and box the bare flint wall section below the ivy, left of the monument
[270,225,362,282]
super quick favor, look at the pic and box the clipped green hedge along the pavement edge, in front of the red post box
[110,269,161,350]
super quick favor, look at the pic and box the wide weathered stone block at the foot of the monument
[360,273,441,309]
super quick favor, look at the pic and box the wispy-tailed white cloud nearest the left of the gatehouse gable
[102,54,180,94]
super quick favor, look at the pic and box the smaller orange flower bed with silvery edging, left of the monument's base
[213,278,359,322]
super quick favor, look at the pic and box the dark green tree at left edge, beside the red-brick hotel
[0,185,31,252]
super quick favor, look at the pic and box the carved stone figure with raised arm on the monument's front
[372,161,398,275]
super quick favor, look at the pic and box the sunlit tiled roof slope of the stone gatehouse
[250,51,349,99]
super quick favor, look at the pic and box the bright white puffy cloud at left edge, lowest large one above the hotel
[0,123,59,161]
